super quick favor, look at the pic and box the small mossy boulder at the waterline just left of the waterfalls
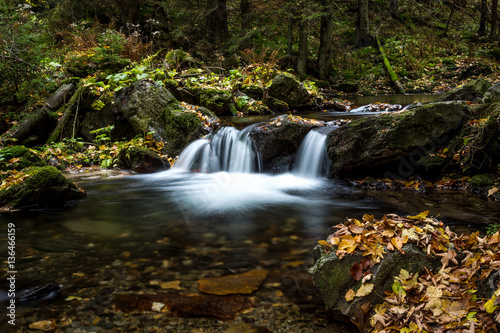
[117,147,170,173]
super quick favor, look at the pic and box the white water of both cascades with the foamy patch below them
[143,125,333,214]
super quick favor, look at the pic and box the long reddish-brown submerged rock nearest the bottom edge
[115,294,253,319]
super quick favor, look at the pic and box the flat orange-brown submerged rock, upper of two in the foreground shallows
[198,270,268,295]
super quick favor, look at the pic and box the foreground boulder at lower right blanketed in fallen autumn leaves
[310,211,500,332]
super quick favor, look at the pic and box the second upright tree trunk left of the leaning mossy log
[318,0,334,80]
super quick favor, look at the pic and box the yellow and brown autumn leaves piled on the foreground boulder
[319,211,500,332]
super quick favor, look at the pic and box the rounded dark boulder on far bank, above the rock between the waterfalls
[269,73,311,108]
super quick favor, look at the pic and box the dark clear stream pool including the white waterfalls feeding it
[0,94,500,333]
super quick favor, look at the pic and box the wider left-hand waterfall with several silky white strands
[174,125,261,173]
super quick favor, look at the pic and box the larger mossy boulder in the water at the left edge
[0,166,86,209]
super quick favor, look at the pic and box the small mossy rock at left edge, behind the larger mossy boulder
[0,146,47,171]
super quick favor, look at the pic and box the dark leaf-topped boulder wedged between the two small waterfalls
[250,115,324,171]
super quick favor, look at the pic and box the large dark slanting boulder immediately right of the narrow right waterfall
[328,102,469,177]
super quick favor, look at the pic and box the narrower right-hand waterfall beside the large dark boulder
[293,126,336,178]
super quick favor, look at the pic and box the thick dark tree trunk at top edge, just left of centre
[207,0,229,46]
